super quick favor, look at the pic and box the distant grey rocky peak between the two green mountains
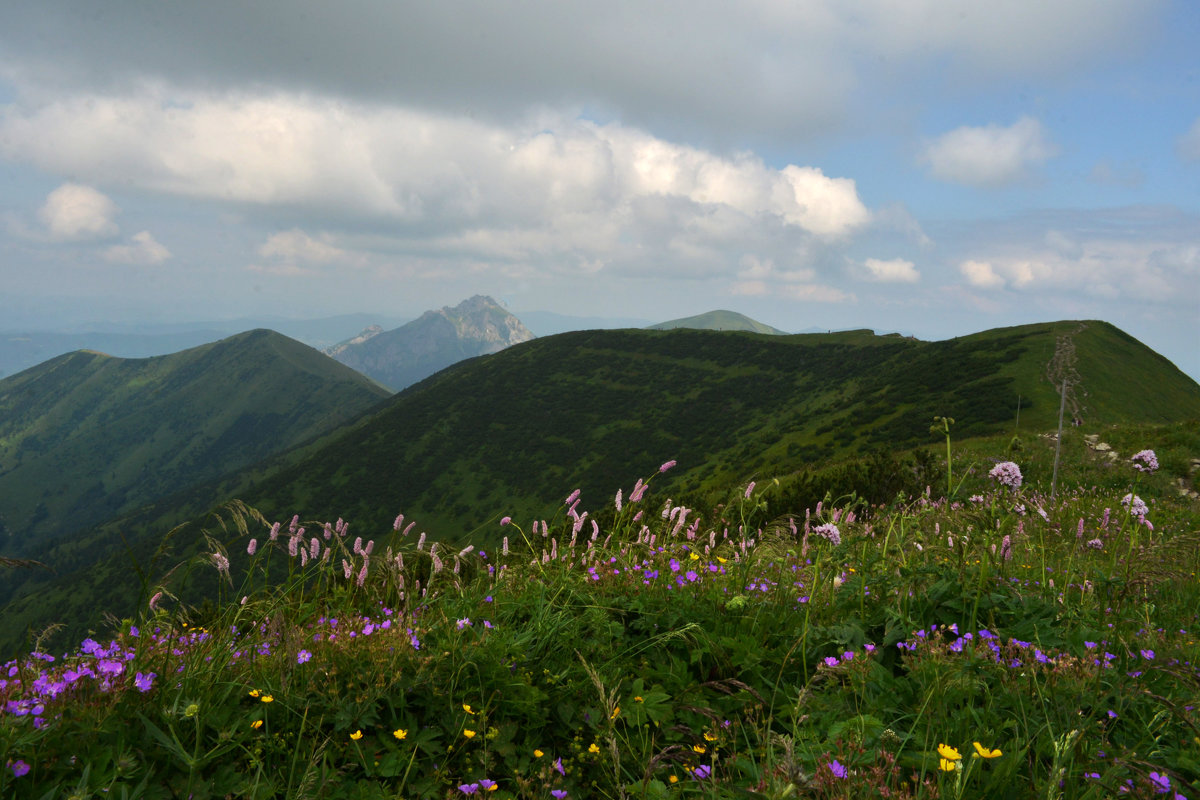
[325,295,534,391]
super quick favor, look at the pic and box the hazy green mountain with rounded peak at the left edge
[0,330,389,558]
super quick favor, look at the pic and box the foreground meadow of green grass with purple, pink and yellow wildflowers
[0,434,1200,798]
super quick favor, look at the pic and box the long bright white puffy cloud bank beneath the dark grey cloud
[0,85,871,286]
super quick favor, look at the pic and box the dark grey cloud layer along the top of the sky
[0,0,1166,143]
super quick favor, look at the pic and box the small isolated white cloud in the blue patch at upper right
[922,116,1057,186]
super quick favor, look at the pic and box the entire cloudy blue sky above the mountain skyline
[0,0,1200,379]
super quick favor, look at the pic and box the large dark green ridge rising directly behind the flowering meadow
[0,321,1200,642]
